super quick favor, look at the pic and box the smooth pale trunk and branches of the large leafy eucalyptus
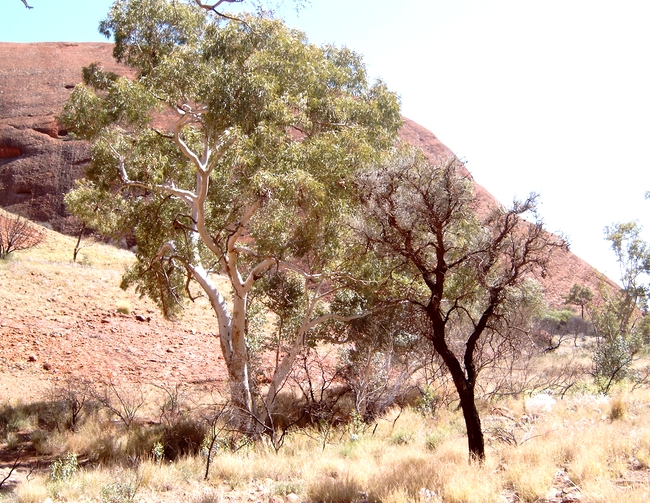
[142,110,367,433]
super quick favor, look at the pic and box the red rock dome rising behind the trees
[0,43,600,305]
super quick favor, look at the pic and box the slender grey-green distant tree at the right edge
[591,222,650,393]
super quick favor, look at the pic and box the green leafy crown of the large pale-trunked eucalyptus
[60,0,401,313]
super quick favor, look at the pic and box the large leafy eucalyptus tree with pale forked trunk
[61,0,401,434]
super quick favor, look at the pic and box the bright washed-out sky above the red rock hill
[0,0,650,280]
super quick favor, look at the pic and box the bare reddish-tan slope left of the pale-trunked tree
[0,210,226,400]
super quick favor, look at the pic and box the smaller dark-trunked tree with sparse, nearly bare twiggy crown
[357,148,564,461]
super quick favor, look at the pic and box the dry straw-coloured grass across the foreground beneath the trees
[0,391,650,503]
